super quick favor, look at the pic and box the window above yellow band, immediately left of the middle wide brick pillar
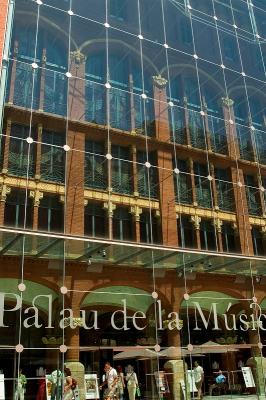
[137,151,158,198]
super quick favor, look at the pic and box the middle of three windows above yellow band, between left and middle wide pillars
[112,145,133,194]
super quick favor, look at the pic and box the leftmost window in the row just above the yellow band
[8,124,36,177]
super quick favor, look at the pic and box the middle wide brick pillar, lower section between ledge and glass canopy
[157,149,178,247]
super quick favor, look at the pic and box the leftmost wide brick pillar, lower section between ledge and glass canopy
[65,130,85,235]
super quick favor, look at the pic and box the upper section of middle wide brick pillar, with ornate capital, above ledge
[153,75,170,143]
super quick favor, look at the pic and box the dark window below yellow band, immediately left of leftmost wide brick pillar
[38,194,64,232]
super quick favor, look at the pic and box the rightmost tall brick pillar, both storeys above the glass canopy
[222,98,253,255]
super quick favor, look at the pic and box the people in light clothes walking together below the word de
[100,362,139,400]
